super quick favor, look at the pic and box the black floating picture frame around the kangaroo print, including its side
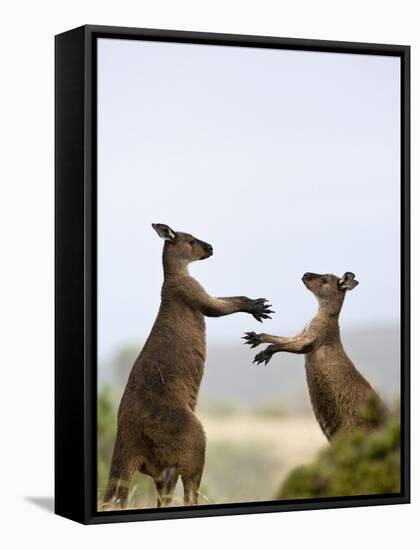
[55,25,410,524]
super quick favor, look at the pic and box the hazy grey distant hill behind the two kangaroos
[99,325,400,413]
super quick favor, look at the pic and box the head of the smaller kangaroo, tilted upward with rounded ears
[302,271,359,303]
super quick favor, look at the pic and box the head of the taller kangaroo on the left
[152,223,213,267]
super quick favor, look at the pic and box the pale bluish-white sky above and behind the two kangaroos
[98,39,400,368]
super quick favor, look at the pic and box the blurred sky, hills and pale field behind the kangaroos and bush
[98,35,400,507]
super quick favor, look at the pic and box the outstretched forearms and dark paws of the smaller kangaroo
[244,332,315,365]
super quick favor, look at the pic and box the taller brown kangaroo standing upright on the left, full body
[104,224,273,508]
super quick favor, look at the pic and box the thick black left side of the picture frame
[54,27,86,523]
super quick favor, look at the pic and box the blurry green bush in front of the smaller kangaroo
[276,416,400,499]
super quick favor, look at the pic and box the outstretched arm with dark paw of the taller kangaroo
[176,279,274,322]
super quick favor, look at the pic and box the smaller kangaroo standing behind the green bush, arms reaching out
[244,271,386,440]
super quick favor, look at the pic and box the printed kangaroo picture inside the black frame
[96,38,401,513]
